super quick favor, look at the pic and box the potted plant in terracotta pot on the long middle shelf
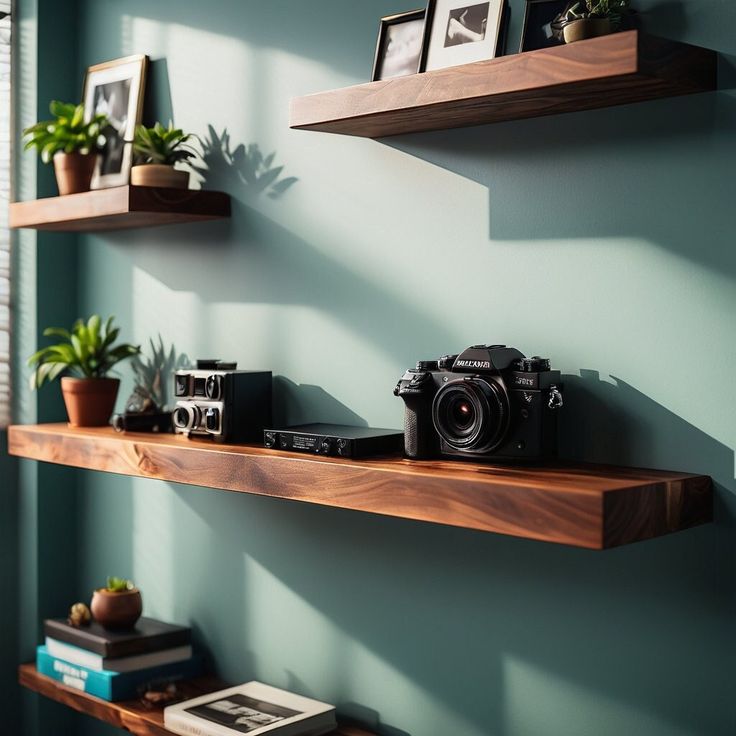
[28,314,140,427]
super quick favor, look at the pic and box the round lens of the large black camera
[432,378,509,452]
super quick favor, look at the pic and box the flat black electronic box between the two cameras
[263,424,404,458]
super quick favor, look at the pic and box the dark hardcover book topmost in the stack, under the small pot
[44,618,192,658]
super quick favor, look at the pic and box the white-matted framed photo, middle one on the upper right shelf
[422,0,505,71]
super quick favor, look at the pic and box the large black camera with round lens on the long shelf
[394,345,562,462]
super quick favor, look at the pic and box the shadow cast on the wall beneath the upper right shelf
[383,87,736,277]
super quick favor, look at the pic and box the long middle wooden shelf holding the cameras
[8,424,713,549]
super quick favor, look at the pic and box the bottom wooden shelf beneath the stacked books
[18,664,375,736]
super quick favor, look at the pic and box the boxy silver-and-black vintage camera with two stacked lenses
[172,360,271,442]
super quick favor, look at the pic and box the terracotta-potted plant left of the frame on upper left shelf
[23,100,107,195]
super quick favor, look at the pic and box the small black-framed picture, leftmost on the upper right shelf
[371,8,426,82]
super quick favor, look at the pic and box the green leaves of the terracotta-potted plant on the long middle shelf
[28,314,140,388]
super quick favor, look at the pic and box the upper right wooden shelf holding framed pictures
[290,31,717,138]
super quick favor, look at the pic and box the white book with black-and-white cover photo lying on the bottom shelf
[164,681,337,736]
